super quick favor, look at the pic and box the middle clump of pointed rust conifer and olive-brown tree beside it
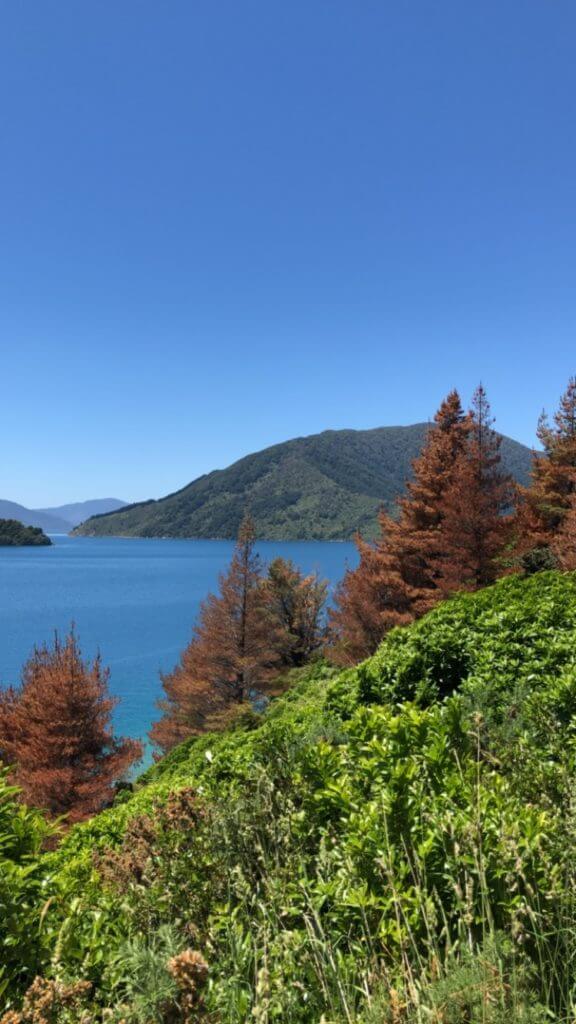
[150,517,327,752]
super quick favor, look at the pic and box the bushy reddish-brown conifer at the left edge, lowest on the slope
[0,630,141,823]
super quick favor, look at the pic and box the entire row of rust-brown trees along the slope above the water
[0,378,576,822]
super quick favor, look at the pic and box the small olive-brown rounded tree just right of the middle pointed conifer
[264,558,328,668]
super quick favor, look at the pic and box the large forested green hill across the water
[75,423,531,541]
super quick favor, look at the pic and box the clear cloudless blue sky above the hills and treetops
[0,0,576,505]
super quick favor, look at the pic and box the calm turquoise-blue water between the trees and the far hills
[0,537,356,753]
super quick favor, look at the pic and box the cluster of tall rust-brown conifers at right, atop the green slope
[330,377,576,664]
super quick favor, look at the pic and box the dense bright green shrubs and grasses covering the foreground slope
[0,572,576,1024]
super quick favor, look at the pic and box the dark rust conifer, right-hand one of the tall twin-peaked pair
[435,385,516,597]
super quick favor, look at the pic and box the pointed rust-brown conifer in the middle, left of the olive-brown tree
[150,519,281,752]
